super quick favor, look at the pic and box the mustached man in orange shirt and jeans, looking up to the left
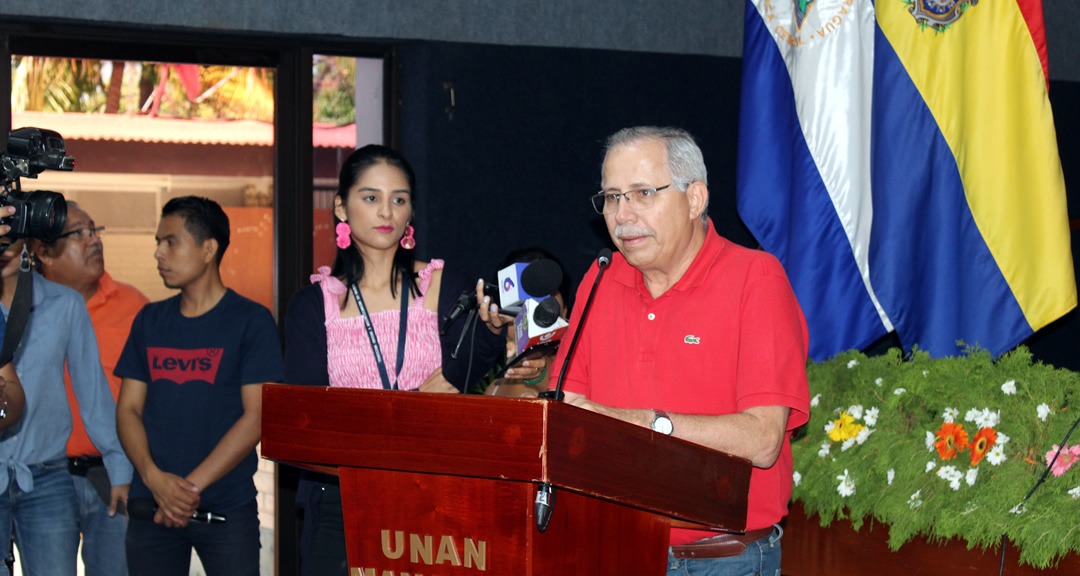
[35,202,149,576]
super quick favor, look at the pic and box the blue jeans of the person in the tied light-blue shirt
[0,458,79,576]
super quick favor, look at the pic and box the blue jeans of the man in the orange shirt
[71,474,127,576]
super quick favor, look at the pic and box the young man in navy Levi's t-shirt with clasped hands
[116,197,282,576]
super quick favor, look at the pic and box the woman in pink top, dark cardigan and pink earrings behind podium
[285,145,502,576]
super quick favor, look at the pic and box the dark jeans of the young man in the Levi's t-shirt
[127,498,259,576]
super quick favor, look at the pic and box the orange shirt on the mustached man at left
[64,272,150,456]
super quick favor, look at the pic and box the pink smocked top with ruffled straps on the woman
[311,259,443,390]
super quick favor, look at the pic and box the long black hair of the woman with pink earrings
[330,144,420,297]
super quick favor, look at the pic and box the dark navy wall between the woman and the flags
[401,43,755,281]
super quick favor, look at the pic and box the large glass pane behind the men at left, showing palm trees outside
[12,55,274,310]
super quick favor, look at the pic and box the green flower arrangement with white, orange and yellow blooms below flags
[792,347,1080,567]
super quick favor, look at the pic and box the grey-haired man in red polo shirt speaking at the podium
[552,126,810,576]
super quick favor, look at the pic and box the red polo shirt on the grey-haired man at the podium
[552,223,810,546]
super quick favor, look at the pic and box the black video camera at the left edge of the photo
[0,128,75,240]
